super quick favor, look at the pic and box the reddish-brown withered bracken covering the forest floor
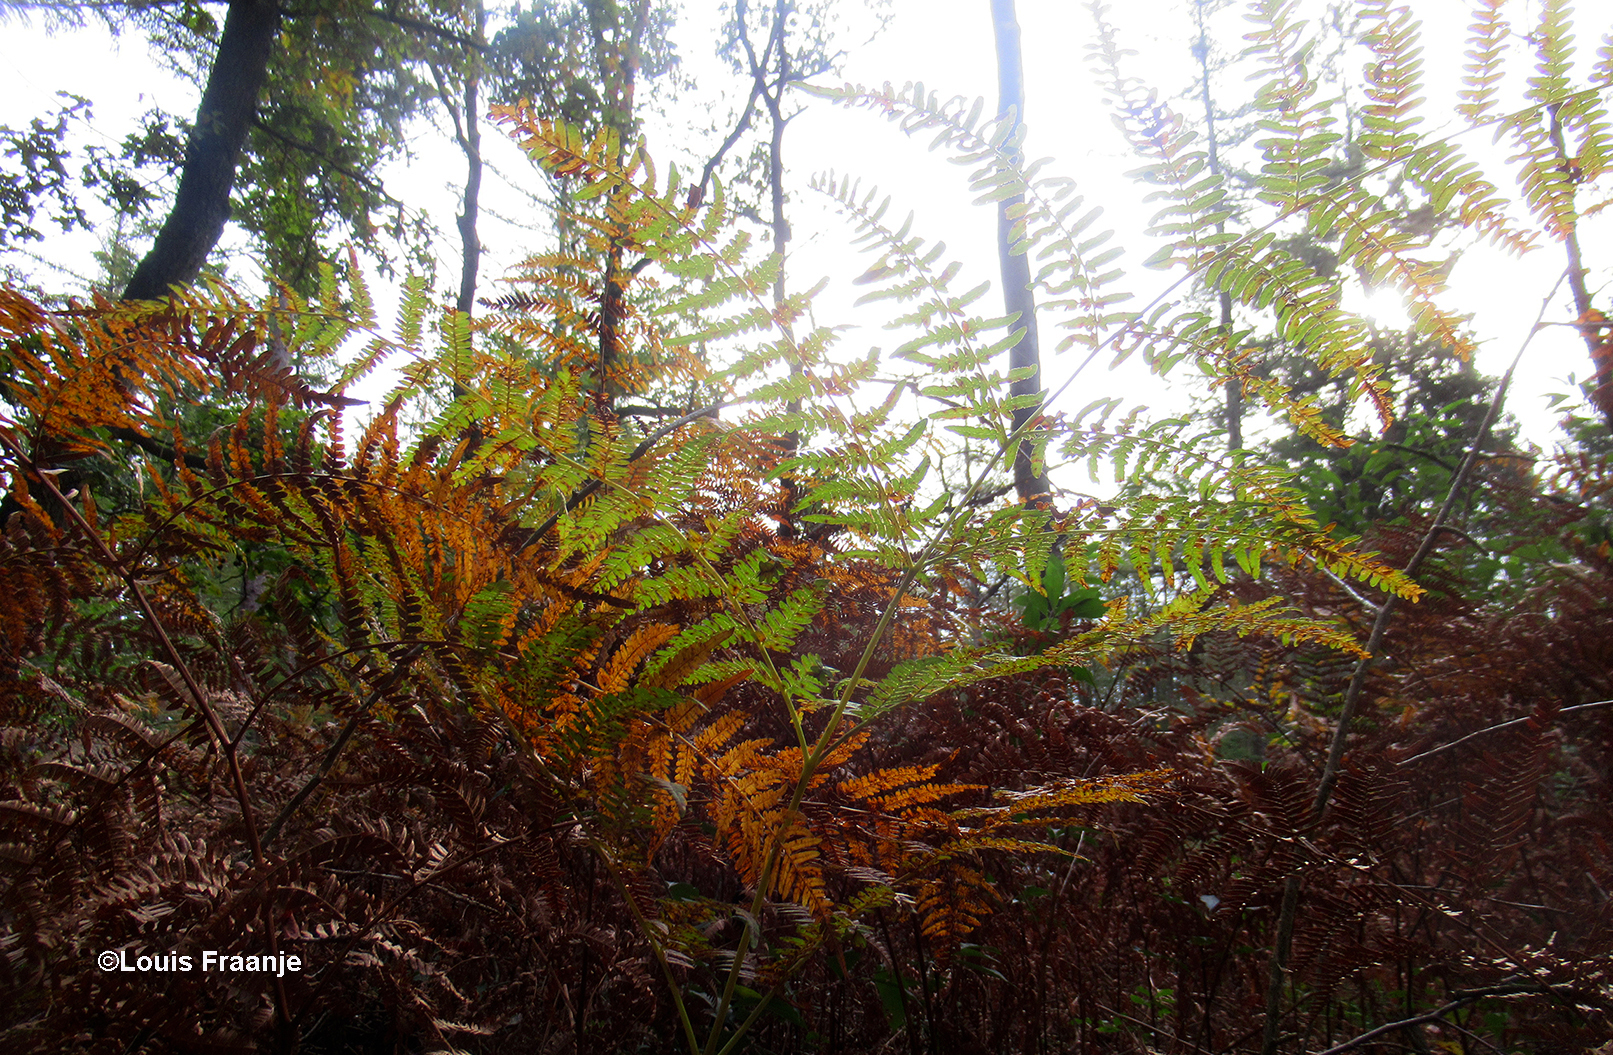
[0,291,1613,1053]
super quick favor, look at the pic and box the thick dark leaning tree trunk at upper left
[123,0,281,300]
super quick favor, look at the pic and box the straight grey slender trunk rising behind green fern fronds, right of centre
[992,0,1048,502]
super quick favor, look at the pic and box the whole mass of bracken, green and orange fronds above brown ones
[0,5,1613,1055]
